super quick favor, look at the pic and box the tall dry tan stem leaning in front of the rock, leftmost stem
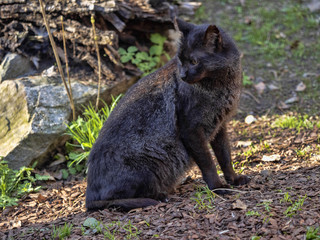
[39,0,75,119]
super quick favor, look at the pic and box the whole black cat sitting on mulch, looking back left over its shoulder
[86,20,248,210]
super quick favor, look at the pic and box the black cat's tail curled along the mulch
[86,198,159,212]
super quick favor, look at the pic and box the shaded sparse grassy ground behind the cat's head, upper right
[202,0,320,115]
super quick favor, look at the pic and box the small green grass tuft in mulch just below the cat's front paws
[191,186,216,211]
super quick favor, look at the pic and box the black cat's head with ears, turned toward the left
[177,19,240,83]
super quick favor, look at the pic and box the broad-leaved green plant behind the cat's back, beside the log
[119,33,170,76]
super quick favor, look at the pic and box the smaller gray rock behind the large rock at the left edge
[0,53,34,82]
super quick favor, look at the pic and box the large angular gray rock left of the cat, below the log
[0,76,135,169]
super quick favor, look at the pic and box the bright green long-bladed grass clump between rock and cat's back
[66,95,121,167]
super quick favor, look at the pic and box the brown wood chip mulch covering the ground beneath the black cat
[0,118,320,240]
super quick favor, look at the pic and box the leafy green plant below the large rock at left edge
[0,159,48,209]
